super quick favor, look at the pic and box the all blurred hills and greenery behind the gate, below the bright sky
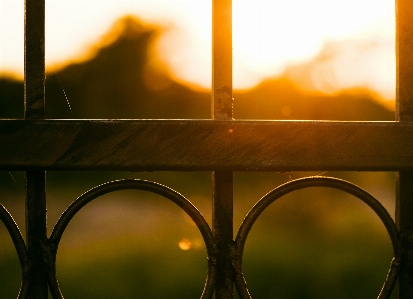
[0,17,394,299]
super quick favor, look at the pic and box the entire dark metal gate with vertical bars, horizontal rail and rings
[0,0,413,299]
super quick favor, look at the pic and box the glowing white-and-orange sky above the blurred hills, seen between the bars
[0,0,395,99]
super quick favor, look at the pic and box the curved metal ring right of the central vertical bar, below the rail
[234,176,402,299]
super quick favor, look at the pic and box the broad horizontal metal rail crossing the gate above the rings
[0,120,413,171]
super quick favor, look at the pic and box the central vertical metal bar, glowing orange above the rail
[212,0,234,299]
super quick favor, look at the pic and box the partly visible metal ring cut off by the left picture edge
[0,204,29,299]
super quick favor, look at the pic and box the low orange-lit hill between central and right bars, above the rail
[235,77,394,121]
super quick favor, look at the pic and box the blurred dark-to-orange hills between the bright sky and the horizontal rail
[0,16,394,120]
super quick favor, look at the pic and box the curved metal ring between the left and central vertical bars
[49,179,216,299]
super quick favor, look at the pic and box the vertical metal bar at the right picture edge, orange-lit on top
[396,0,413,299]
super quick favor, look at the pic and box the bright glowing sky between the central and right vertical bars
[233,0,395,99]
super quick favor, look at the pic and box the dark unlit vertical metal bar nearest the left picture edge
[24,0,48,299]
